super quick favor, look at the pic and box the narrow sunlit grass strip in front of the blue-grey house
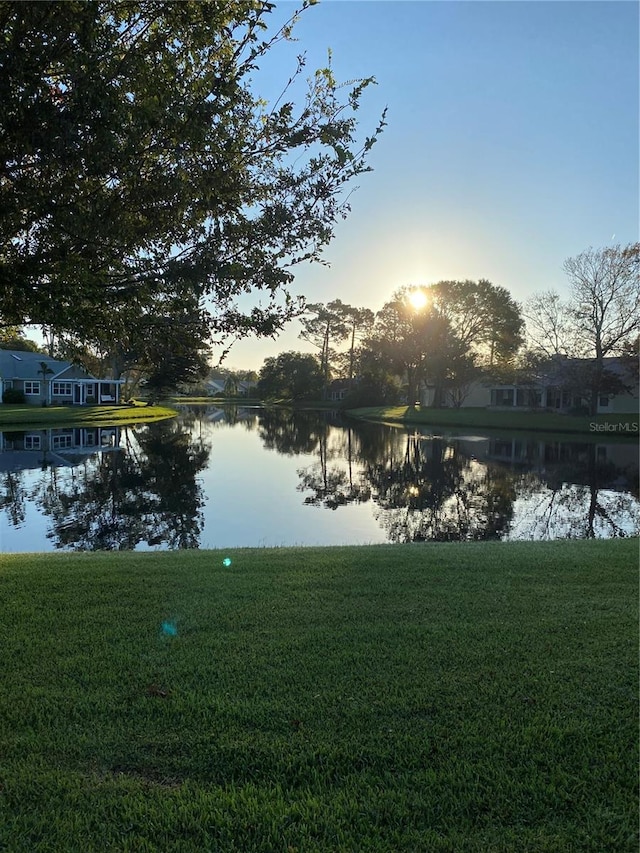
[0,403,176,430]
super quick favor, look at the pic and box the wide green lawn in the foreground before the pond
[0,540,638,853]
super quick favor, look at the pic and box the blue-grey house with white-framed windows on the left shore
[0,349,124,406]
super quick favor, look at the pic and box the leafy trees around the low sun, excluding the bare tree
[258,280,523,405]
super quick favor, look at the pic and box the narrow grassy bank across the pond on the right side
[349,406,640,441]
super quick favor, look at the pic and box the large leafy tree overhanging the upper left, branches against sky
[0,0,384,348]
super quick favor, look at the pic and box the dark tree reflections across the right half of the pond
[298,416,639,542]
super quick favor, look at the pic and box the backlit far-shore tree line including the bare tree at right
[258,244,640,412]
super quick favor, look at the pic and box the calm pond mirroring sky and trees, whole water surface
[0,406,640,552]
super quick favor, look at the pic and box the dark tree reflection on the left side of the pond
[1,421,209,551]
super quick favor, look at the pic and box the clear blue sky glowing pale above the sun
[226,0,639,369]
